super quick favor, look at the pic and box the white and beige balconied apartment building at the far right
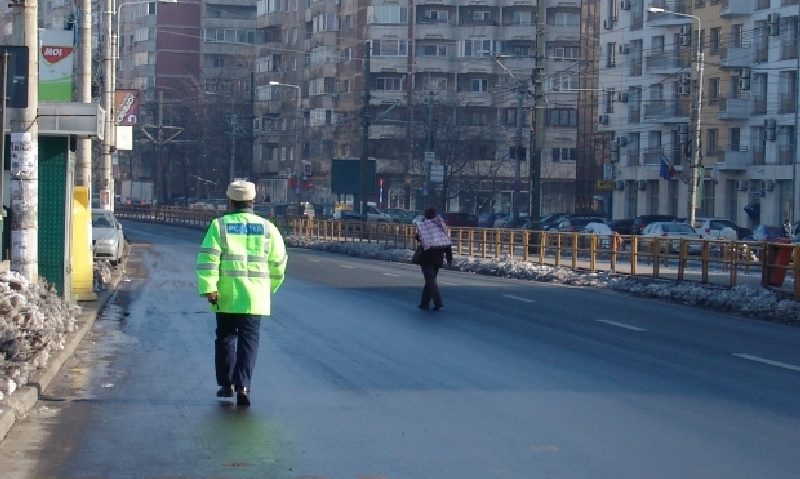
[597,0,798,226]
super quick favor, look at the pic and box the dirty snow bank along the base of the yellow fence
[286,236,800,324]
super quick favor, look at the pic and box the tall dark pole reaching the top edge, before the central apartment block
[530,2,547,221]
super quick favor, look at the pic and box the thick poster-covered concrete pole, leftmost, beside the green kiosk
[11,0,39,282]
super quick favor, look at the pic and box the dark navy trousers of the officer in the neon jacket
[214,313,264,391]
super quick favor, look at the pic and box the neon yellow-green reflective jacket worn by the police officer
[197,210,288,315]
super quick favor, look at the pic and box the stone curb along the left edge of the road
[0,270,122,441]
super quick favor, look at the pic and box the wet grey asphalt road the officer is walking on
[0,222,800,479]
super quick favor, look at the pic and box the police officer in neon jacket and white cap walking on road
[197,181,288,406]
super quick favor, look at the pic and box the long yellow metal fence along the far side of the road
[116,206,800,298]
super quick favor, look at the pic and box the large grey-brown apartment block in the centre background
[253,0,580,212]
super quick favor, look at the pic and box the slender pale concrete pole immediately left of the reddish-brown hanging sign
[99,0,114,211]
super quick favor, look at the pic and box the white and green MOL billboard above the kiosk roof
[39,30,75,103]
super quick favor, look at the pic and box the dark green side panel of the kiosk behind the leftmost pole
[39,136,69,297]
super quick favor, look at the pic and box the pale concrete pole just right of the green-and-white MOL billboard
[75,0,92,189]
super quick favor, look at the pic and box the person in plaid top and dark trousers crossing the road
[416,208,453,311]
